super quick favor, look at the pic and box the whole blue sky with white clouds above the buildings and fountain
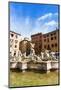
[9,2,58,38]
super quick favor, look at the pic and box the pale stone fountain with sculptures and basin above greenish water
[10,39,58,73]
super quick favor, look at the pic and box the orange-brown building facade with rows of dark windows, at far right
[42,30,59,52]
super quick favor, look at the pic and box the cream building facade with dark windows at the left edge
[10,31,22,56]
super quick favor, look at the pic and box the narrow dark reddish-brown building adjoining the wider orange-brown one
[31,33,42,54]
